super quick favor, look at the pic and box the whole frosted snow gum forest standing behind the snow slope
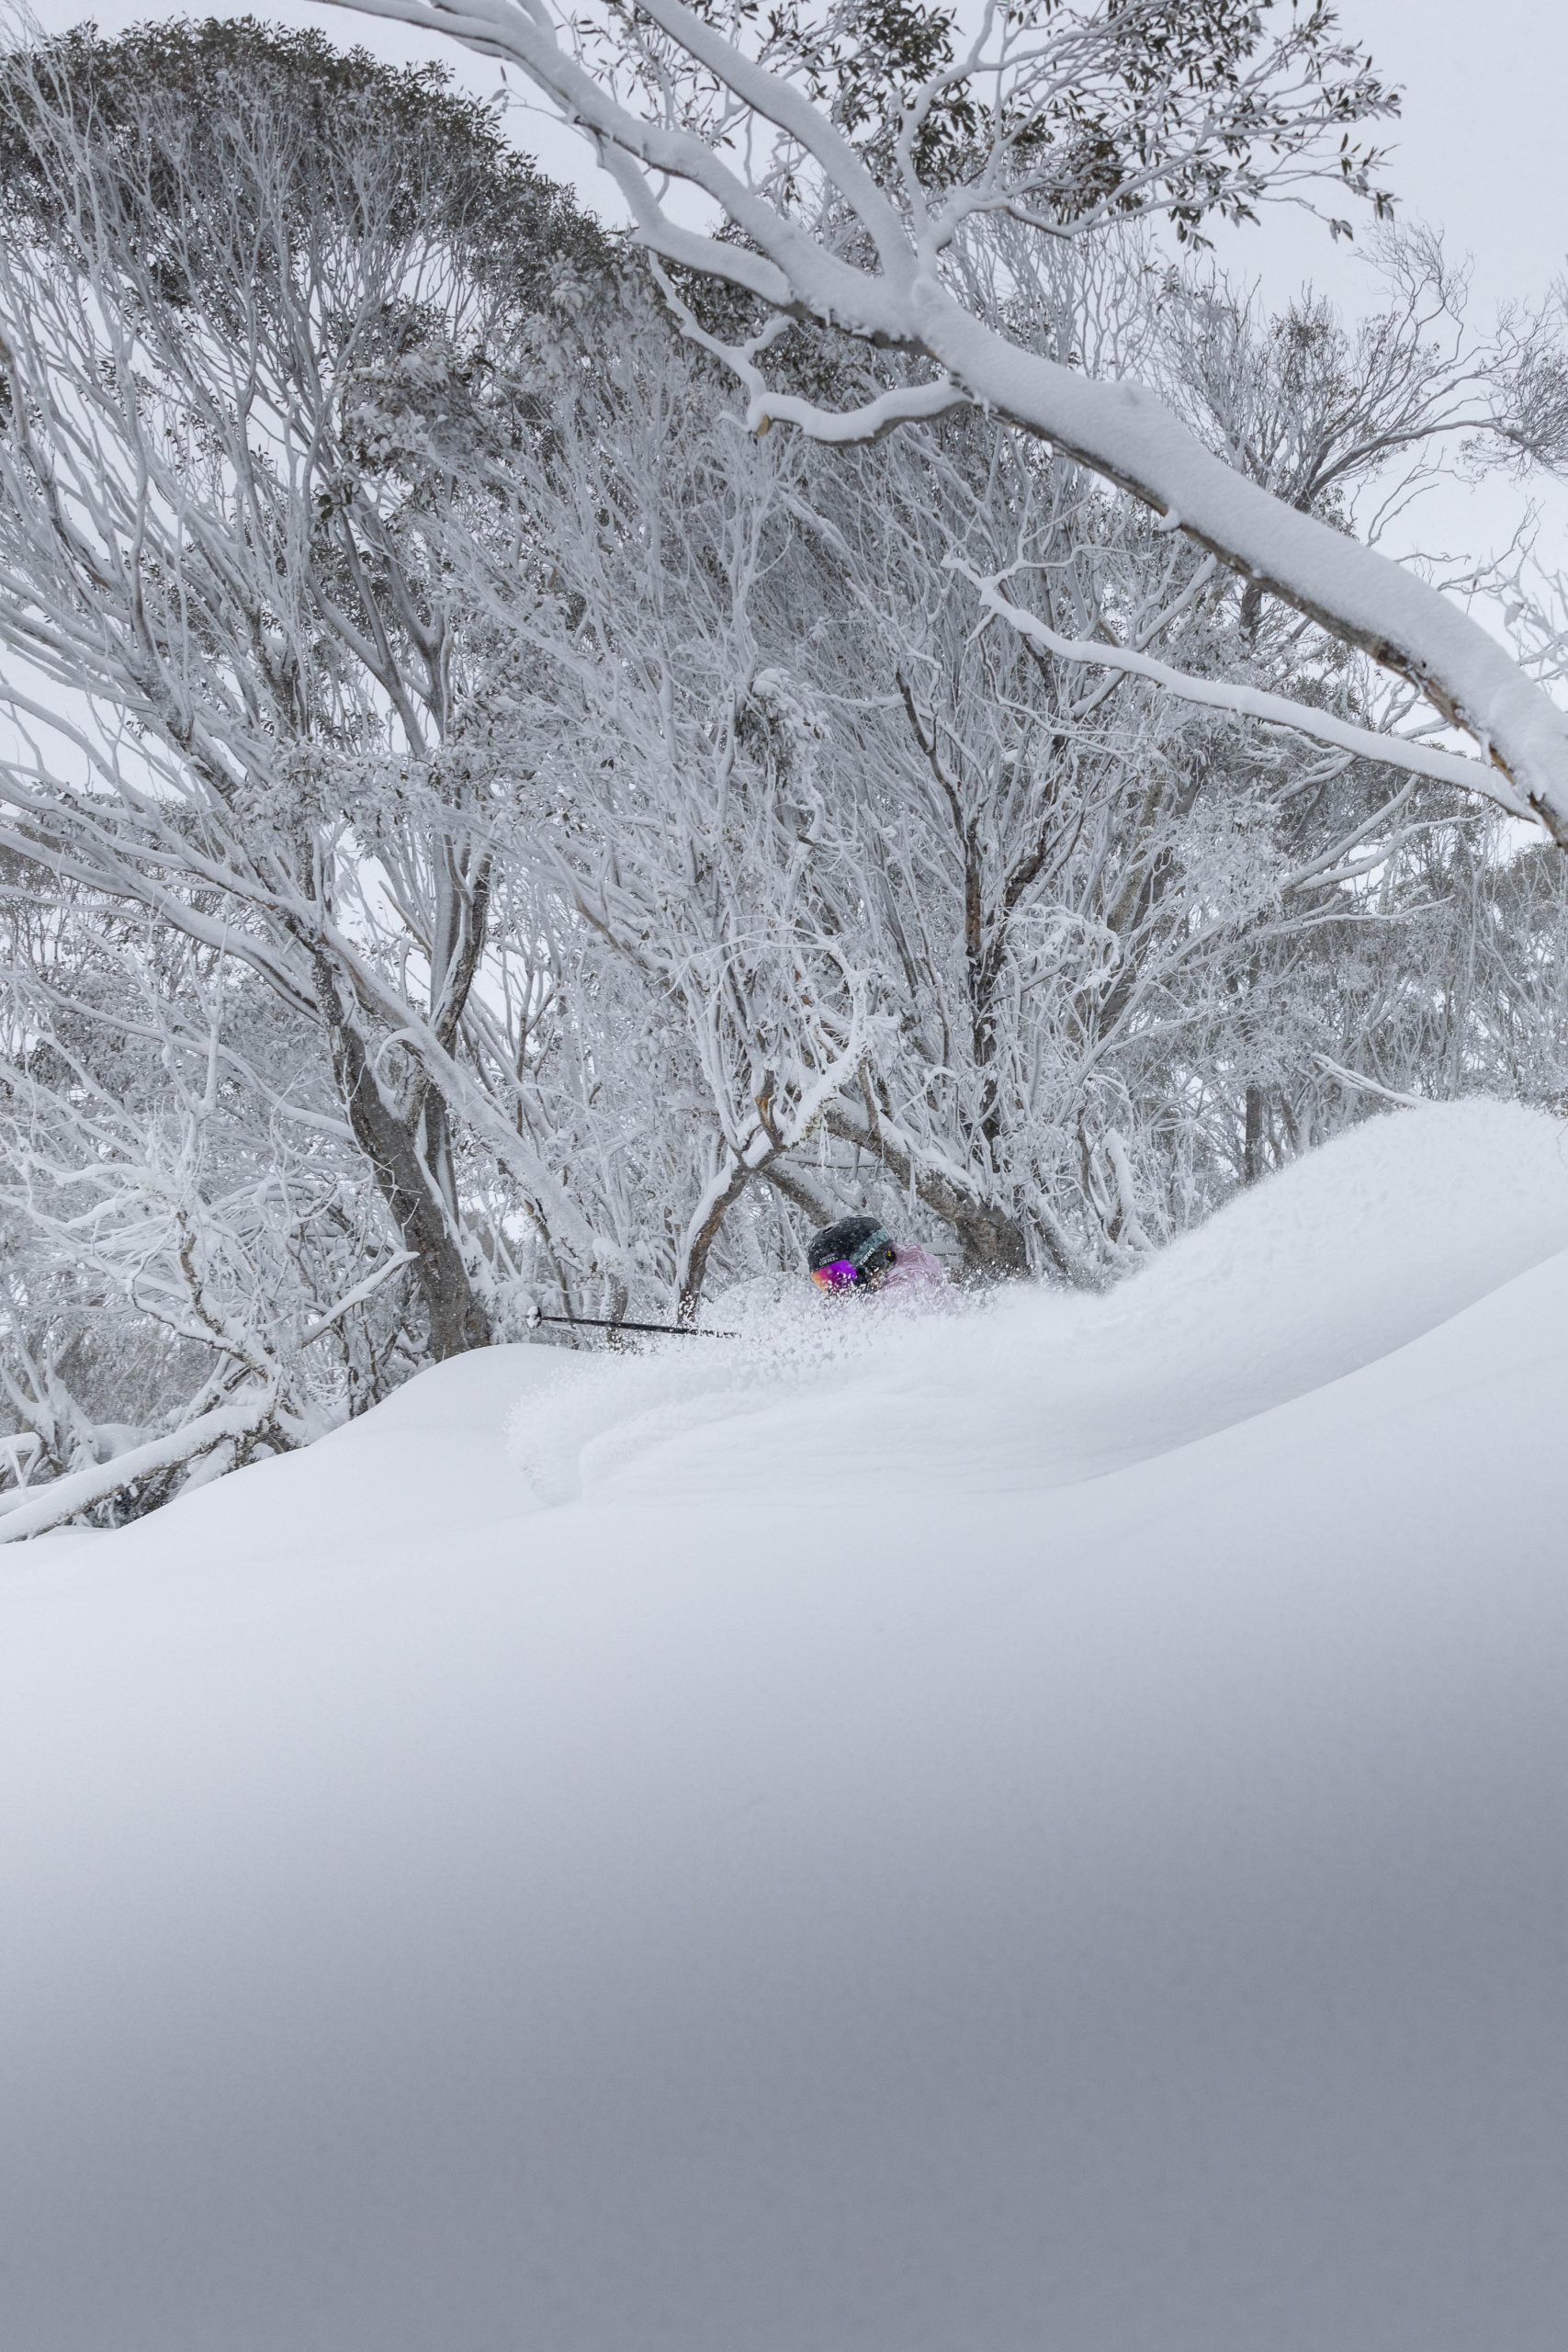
[0,0,1568,1524]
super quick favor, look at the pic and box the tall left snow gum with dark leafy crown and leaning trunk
[0,24,611,1357]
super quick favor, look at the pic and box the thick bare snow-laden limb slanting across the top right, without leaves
[336,0,1568,847]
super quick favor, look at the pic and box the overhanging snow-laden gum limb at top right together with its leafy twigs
[321,0,1568,842]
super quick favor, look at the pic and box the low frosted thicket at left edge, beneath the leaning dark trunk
[0,861,407,1532]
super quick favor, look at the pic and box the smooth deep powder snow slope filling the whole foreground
[0,1105,1568,2352]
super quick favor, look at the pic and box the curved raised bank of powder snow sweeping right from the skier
[508,1099,1568,1505]
